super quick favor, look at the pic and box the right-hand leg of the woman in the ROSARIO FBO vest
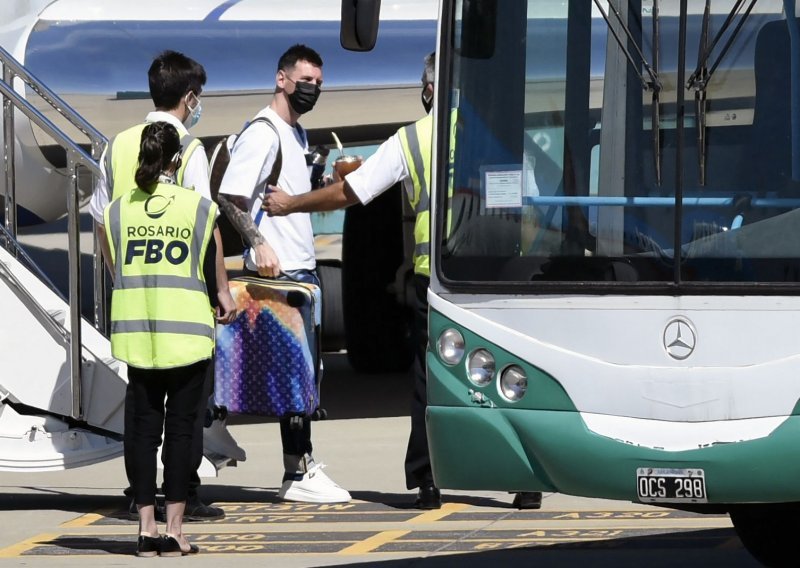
[161,359,210,550]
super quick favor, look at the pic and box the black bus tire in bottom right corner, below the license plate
[730,503,800,566]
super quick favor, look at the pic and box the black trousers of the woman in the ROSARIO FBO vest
[124,359,206,504]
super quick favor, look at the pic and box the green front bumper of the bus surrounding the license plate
[427,405,800,504]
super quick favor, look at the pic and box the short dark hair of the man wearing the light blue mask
[147,50,206,110]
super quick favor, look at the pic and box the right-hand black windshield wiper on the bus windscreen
[686,0,758,185]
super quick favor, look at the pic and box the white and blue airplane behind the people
[0,0,436,224]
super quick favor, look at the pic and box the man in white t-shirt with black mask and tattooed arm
[218,45,350,503]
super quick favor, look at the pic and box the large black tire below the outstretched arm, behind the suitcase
[342,184,414,373]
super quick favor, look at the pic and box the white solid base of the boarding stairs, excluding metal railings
[0,227,246,477]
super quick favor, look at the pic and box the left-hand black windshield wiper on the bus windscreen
[594,0,662,185]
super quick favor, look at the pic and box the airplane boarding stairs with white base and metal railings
[0,42,246,477]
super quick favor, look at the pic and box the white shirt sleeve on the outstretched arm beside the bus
[345,129,414,204]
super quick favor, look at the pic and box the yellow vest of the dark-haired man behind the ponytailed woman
[103,122,202,203]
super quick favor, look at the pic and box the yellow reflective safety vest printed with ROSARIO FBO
[103,184,217,369]
